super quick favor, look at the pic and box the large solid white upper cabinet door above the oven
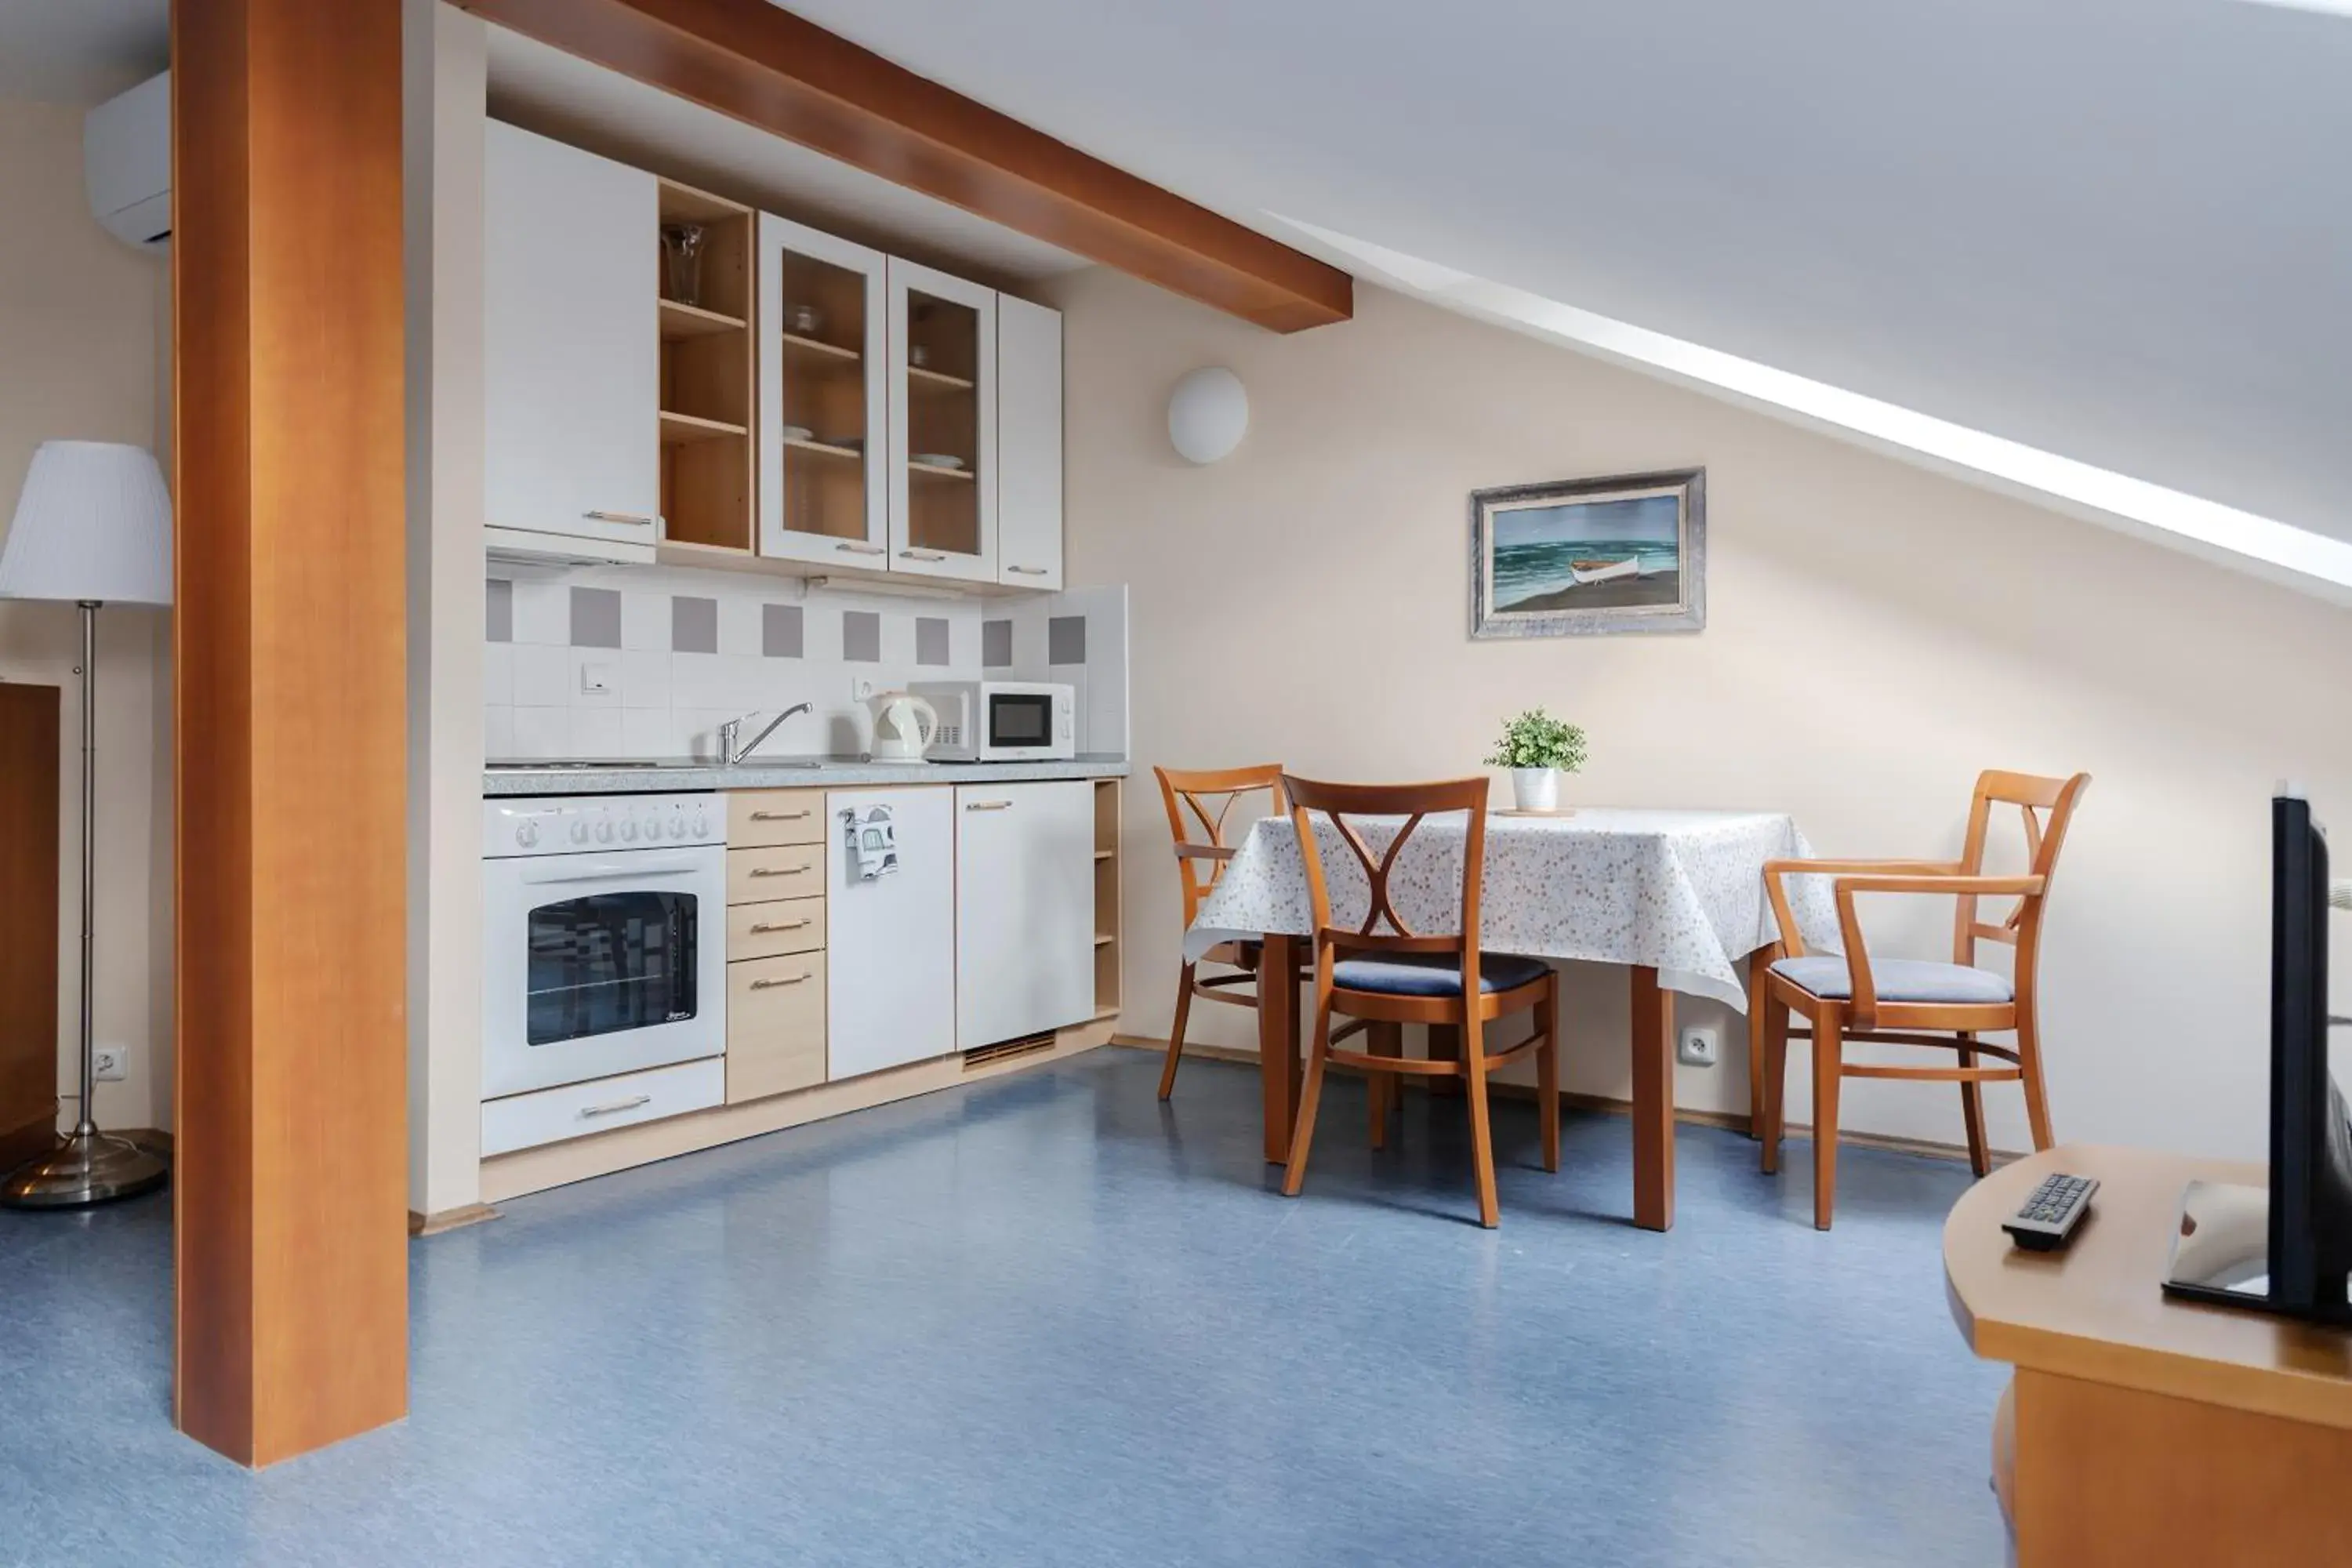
[482,120,661,560]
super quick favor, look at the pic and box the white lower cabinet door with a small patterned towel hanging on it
[826,785,955,1081]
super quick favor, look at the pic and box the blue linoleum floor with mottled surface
[0,1048,2002,1568]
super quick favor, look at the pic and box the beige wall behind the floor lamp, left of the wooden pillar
[0,99,172,1126]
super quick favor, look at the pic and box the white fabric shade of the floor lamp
[0,442,172,604]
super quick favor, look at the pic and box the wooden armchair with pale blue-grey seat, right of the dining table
[1755,771,2091,1229]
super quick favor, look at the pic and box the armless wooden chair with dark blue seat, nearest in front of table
[1282,779,1559,1229]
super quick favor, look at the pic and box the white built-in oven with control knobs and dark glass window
[482,794,727,1100]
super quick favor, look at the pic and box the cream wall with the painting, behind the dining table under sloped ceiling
[1054,270,2352,1156]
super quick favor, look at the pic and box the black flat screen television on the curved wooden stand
[2164,789,2352,1323]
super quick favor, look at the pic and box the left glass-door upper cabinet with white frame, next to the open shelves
[757,214,889,572]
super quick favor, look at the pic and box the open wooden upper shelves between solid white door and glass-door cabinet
[652,179,757,553]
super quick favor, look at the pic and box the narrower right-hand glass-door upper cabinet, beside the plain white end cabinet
[887,256,997,583]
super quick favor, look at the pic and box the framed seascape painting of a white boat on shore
[1470,468,1708,637]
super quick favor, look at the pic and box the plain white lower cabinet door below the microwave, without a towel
[955,779,1096,1051]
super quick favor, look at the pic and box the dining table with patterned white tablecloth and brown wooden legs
[1183,806,1842,1229]
